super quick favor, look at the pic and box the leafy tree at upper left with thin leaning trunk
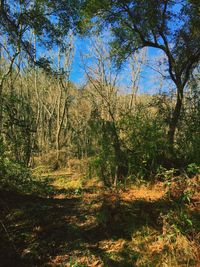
[0,0,79,130]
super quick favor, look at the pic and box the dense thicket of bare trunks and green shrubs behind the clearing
[1,50,200,186]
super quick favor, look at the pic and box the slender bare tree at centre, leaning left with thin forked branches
[84,39,128,186]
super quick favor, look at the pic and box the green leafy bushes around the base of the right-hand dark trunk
[87,95,199,185]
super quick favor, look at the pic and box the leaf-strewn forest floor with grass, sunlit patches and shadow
[0,170,200,267]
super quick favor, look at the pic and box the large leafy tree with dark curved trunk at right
[82,0,200,151]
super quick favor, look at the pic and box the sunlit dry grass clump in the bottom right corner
[129,226,198,267]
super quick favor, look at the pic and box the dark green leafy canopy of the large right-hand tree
[82,0,200,66]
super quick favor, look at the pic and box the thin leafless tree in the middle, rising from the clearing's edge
[84,40,127,186]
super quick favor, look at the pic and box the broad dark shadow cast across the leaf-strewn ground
[0,177,198,267]
